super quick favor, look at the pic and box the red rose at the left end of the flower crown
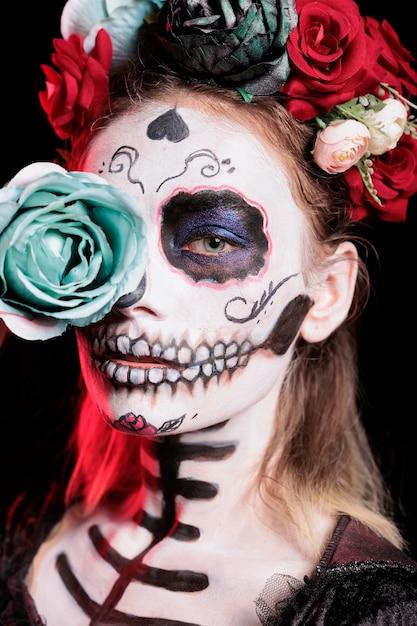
[39,29,112,140]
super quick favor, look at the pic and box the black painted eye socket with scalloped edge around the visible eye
[161,190,268,283]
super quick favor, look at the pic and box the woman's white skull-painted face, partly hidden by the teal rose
[77,105,308,434]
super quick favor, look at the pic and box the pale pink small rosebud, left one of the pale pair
[313,120,370,174]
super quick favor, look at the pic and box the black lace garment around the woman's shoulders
[0,498,417,626]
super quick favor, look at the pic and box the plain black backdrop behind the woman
[0,0,417,558]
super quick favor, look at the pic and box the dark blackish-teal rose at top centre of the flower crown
[157,0,297,95]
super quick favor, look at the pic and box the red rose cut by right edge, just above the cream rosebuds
[365,17,417,99]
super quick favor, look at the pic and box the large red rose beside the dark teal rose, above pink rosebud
[281,0,380,121]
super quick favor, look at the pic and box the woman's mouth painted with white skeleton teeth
[93,335,255,386]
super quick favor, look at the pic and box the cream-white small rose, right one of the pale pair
[363,98,408,155]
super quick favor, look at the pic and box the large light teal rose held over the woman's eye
[0,163,145,340]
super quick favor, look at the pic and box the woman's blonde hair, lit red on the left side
[67,72,403,552]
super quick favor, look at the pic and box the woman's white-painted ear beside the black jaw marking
[300,241,358,343]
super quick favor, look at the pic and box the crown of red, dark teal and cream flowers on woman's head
[39,0,417,222]
